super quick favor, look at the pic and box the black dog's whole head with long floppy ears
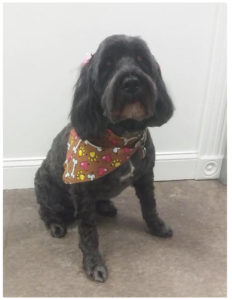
[71,35,173,138]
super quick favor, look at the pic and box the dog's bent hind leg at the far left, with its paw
[35,165,74,238]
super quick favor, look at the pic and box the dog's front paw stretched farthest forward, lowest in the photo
[83,257,108,282]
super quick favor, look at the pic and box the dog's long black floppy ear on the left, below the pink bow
[70,59,105,139]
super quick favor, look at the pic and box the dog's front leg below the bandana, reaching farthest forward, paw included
[71,192,107,282]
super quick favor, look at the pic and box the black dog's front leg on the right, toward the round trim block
[134,171,173,237]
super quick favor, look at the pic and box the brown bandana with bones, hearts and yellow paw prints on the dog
[63,129,147,184]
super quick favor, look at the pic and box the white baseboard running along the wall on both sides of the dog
[3,152,222,189]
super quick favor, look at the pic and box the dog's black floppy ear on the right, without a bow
[148,56,174,126]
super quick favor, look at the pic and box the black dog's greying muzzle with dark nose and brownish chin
[104,71,156,123]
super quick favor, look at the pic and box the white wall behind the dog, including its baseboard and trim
[4,3,226,188]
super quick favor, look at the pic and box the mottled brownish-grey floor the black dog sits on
[4,180,226,297]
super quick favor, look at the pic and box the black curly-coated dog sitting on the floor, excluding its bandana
[35,35,173,281]
